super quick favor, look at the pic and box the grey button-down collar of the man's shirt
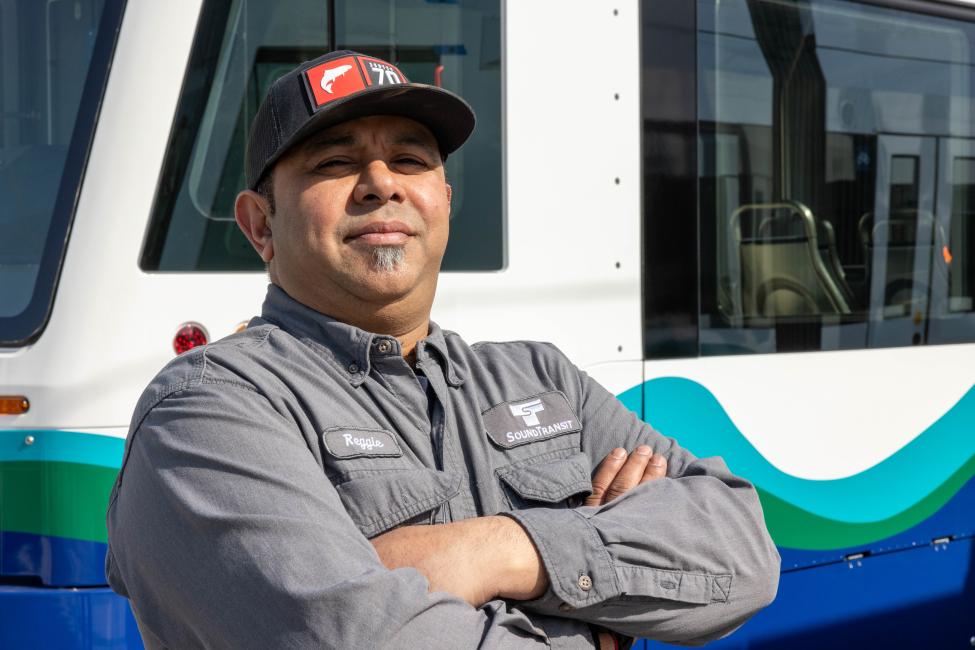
[255,284,464,386]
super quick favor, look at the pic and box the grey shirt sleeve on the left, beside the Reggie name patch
[106,383,593,650]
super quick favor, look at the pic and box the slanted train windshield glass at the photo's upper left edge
[0,0,124,346]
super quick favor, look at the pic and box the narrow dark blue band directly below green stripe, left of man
[0,531,108,584]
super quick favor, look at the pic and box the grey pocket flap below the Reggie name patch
[335,468,461,537]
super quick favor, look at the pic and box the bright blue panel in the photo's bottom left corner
[0,586,142,650]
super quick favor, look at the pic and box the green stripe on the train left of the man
[0,461,118,543]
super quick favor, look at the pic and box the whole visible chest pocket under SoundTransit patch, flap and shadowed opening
[495,450,592,510]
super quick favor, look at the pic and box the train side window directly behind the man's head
[141,0,504,271]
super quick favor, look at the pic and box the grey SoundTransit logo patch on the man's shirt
[481,391,582,449]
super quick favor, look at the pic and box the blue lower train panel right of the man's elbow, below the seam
[634,538,975,650]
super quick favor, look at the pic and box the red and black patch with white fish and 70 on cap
[302,56,407,110]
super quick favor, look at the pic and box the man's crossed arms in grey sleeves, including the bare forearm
[107,372,778,648]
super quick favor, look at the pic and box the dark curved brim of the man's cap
[251,83,475,189]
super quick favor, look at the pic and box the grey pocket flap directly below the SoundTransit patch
[497,453,592,503]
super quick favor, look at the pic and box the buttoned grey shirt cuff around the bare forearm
[500,508,621,616]
